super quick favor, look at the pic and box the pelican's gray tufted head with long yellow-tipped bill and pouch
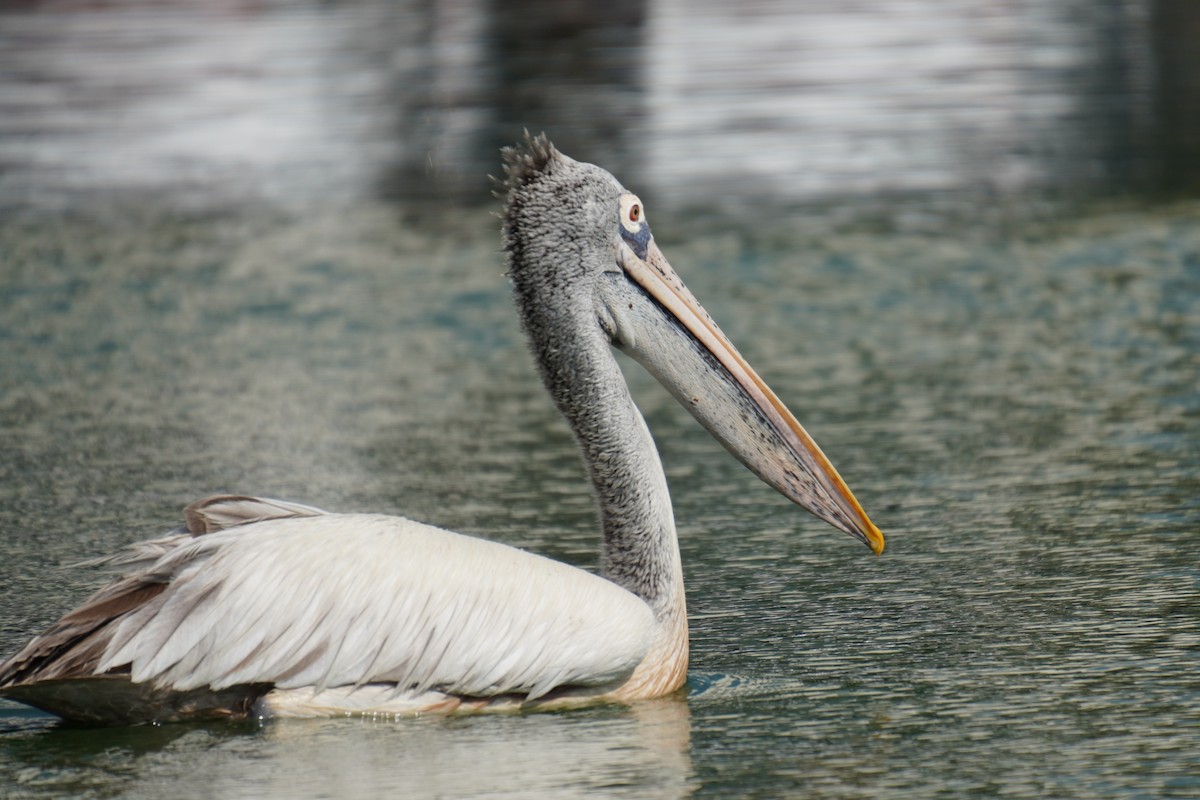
[502,136,883,553]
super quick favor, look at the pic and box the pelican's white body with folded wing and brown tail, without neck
[0,498,654,722]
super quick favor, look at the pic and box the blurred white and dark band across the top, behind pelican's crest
[0,0,1200,219]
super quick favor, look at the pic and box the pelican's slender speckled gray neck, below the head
[533,324,684,620]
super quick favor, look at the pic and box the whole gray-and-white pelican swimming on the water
[0,134,883,724]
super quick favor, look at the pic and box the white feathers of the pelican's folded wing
[98,509,654,698]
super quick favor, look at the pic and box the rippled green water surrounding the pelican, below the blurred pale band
[0,196,1200,798]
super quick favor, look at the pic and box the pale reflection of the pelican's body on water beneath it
[6,698,694,798]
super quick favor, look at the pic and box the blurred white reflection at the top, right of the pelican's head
[647,0,1151,199]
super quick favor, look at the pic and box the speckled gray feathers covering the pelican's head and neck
[504,139,682,614]
